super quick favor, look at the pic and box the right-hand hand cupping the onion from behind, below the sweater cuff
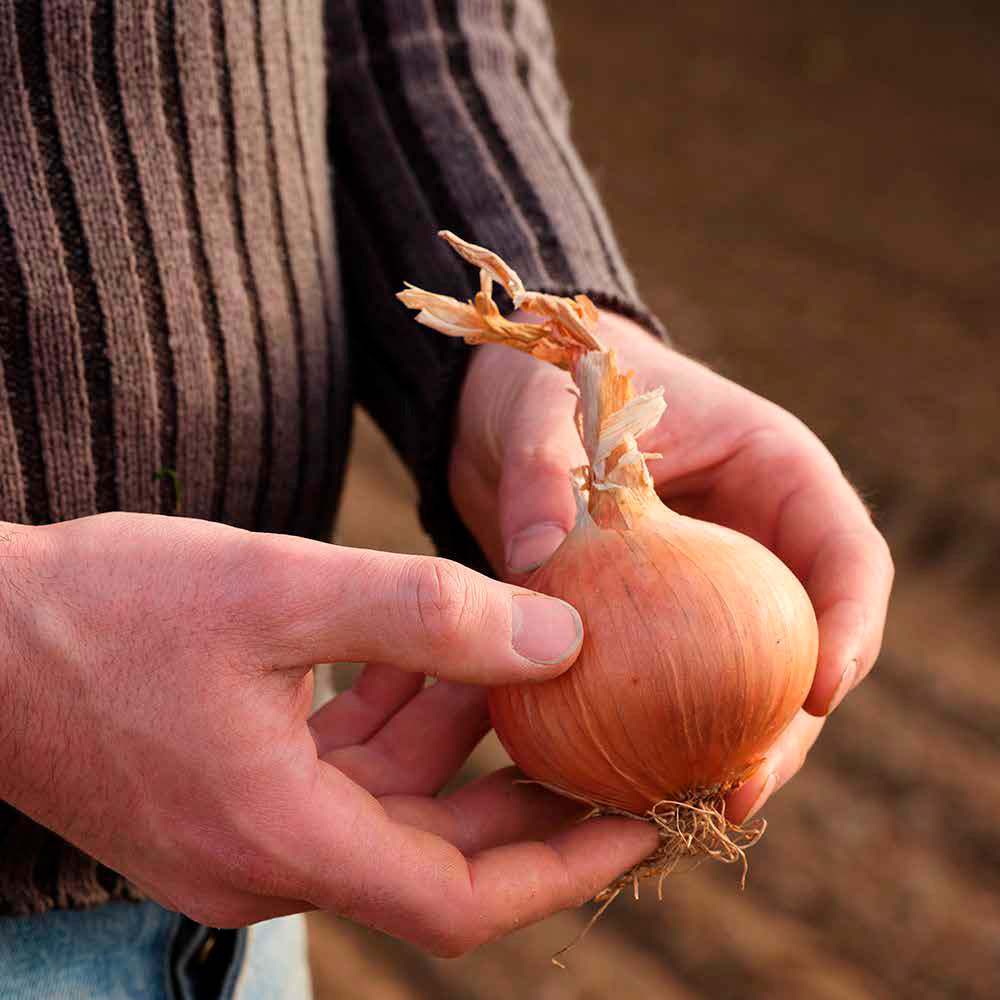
[451,313,893,820]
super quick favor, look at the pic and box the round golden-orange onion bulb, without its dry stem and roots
[489,500,818,814]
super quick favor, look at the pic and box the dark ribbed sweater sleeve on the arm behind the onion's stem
[328,0,661,568]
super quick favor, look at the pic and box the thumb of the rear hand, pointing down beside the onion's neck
[498,369,586,580]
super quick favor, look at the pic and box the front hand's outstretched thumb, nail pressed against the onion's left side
[237,535,583,684]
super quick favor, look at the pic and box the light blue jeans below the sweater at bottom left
[0,903,312,1000]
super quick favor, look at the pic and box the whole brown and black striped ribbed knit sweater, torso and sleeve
[0,0,656,913]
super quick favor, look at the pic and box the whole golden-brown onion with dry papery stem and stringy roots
[399,233,818,898]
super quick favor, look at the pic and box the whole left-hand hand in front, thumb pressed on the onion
[0,514,656,955]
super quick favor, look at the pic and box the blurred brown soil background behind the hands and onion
[312,0,1000,1000]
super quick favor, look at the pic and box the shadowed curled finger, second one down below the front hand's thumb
[323,681,490,796]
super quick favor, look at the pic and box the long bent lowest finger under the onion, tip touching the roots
[290,768,659,956]
